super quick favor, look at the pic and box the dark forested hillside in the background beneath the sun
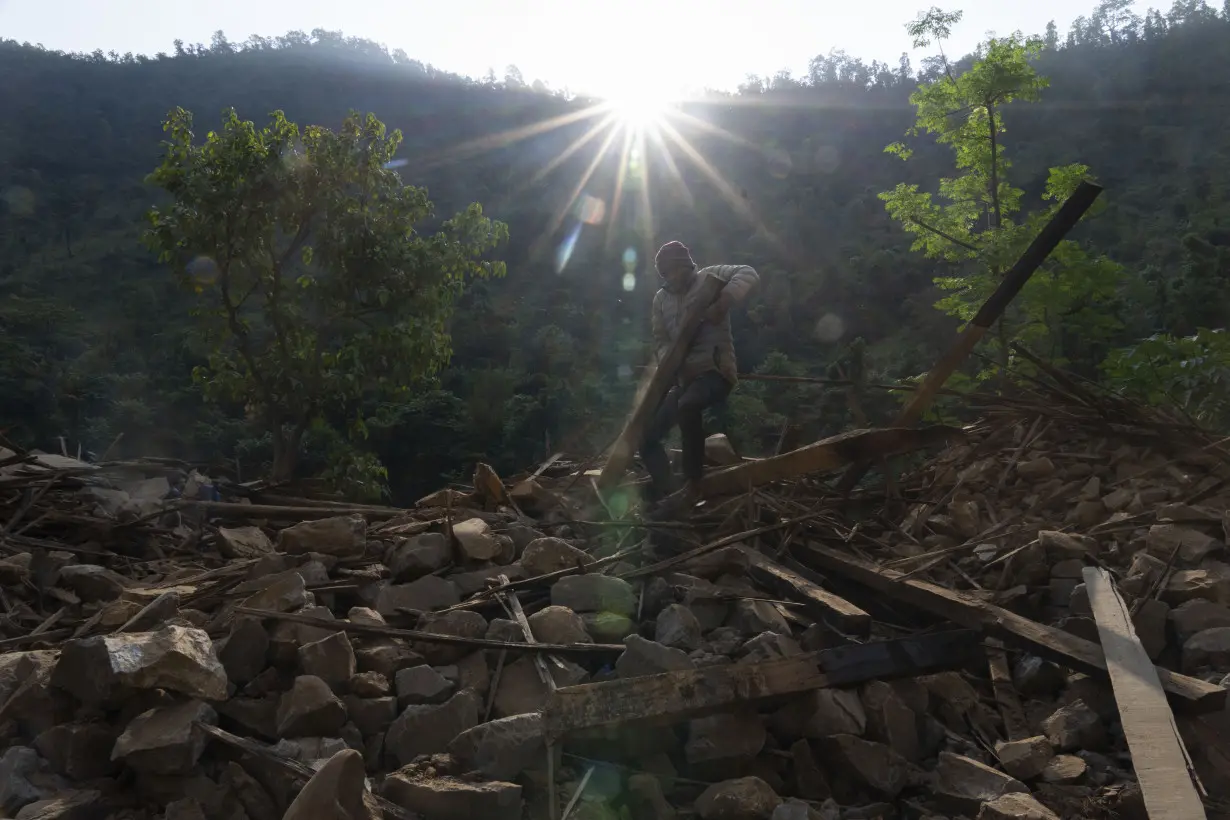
[0,0,1230,500]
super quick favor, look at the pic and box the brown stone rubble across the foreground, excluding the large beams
[0,390,1230,820]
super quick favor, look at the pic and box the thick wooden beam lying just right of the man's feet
[700,424,964,495]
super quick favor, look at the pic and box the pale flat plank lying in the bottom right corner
[1082,567,1205,820]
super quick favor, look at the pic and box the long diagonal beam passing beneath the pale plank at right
[795,542,1226,713]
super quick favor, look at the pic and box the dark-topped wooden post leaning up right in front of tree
[836,182,1102,493]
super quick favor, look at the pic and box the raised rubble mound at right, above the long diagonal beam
[880,398,1230,682]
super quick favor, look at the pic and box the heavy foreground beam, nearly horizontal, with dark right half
[542,629,982,741]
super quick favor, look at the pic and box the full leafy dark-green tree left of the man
[146,108,507,478]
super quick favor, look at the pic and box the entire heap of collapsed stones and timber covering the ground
[0,366,1230,820]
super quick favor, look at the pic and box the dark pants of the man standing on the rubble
[641,370,732,502]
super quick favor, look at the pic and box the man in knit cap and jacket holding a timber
[641,242,760,509]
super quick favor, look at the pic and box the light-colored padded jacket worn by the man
[653,264,760,385]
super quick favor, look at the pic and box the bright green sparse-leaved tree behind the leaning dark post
[879,7,1122,377]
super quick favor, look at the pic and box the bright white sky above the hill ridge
[0,0,1151,96]
